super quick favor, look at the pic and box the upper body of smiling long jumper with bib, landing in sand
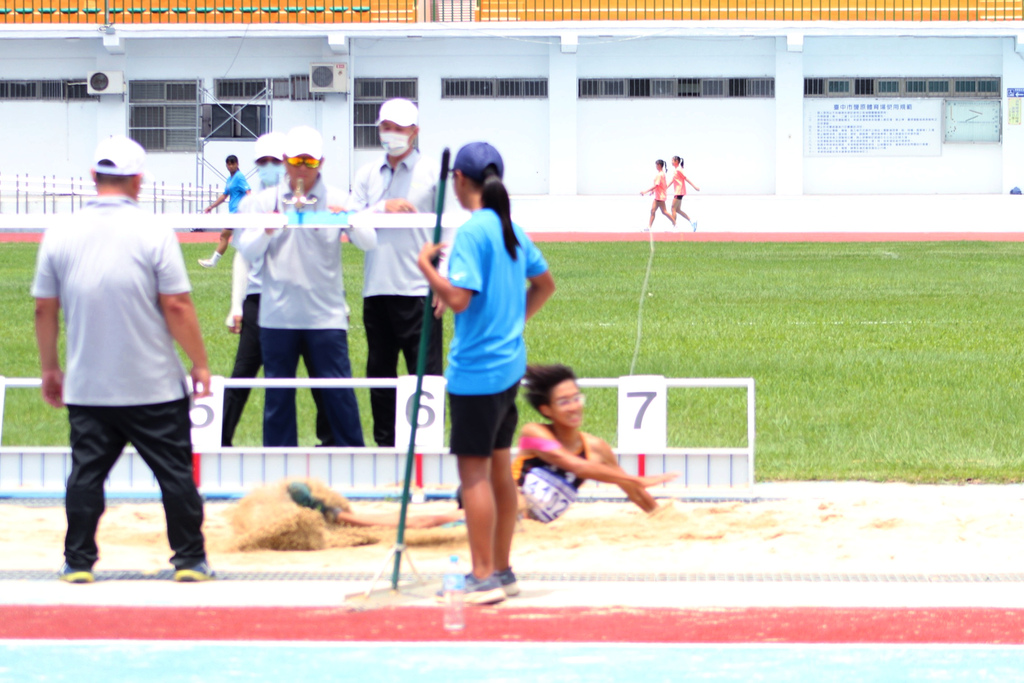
[512,366,679,522]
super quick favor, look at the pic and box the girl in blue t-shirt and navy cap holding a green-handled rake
[419,142,555,604]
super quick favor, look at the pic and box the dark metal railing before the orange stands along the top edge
[0,0,1024,24]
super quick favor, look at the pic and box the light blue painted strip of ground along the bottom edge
[0,640,1024,683]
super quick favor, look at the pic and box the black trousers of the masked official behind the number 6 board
[362,296,443,447]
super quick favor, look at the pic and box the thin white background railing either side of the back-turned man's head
[0,173,222,215]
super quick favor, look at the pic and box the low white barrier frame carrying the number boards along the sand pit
[0,378,756,494]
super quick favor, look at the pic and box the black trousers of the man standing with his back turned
[65,398,206,569]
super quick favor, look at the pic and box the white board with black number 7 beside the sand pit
[617,375,669,453]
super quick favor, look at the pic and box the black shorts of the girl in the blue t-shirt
[449,382,519,458]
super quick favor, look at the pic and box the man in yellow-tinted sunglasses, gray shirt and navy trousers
[237,126,377,446]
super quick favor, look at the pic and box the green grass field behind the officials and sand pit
[0,237,1024,482]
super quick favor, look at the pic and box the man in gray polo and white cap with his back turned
[32,136,214,584]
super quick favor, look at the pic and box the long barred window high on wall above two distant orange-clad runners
[578,78,775,99]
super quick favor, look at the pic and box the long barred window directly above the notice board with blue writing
[804,77,1000,97]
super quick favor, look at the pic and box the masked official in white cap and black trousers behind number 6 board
[345,98,452,447]
